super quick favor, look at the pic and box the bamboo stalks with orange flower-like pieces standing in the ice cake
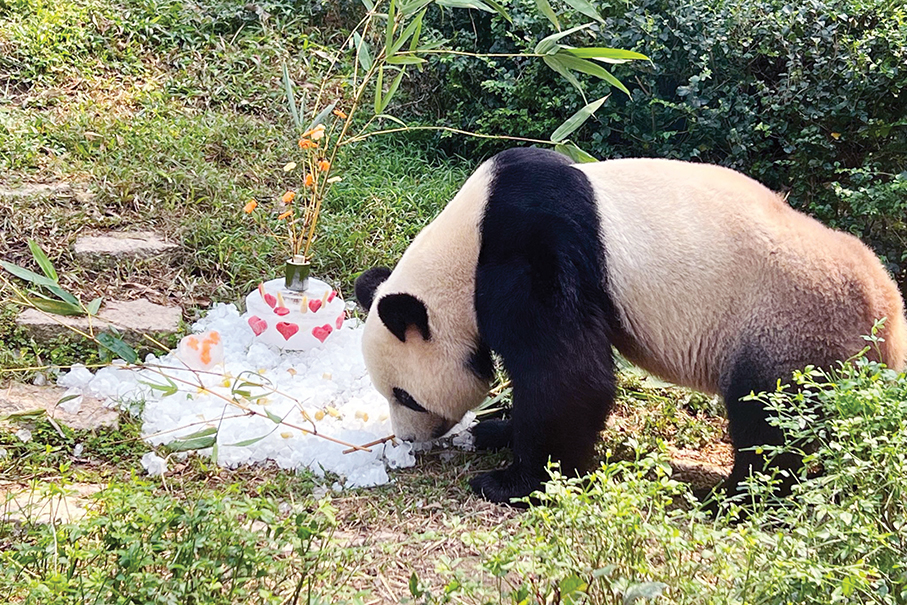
[243,0,647,274]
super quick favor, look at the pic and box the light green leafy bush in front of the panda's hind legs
[448,350,907,605]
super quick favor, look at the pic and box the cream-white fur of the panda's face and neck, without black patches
[362,162,491,440]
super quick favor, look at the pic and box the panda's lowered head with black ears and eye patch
[356,268,493,441]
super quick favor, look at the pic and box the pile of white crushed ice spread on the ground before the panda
[58,304,474,489]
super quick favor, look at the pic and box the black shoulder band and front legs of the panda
[471,149,615,502]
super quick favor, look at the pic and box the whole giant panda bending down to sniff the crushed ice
[355,148,907,503]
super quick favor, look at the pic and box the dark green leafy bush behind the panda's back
[414,0,907,293]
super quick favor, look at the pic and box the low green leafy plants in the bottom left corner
[0,481,343,605]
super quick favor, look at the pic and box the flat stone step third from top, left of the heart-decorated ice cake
[16,300,182,345]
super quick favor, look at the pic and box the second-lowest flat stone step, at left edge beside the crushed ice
[0,382,119,430]
